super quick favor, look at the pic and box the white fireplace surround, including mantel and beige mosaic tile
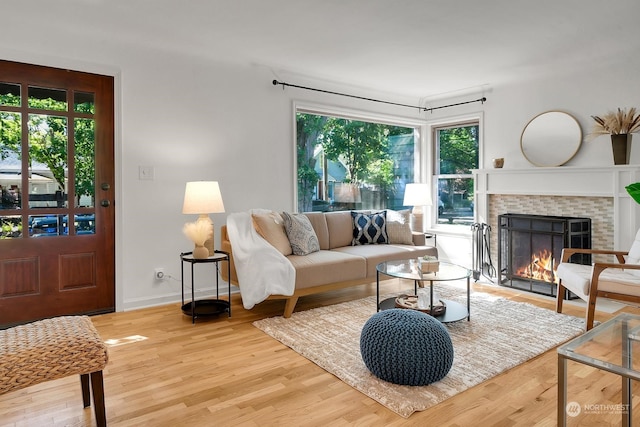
[474,166,640,267]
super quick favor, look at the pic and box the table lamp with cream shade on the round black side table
[182,181,224,257]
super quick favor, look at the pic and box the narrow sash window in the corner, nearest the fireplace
[432,121,479,227]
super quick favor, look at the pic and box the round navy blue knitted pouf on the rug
[360,308,453,385]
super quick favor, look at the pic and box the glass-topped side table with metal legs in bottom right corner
[558,313,640,427]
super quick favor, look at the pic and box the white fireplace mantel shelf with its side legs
[473,165,640,250]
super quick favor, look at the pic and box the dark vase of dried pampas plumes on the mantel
[591,107,640,165]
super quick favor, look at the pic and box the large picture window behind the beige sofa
[296,108,420,212]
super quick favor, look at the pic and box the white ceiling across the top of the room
[6,0,640,99]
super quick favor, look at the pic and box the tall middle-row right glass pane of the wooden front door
[74,119,96,207]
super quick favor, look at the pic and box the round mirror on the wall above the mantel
[520,111,582,166]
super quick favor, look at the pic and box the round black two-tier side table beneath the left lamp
[180,250,231,323]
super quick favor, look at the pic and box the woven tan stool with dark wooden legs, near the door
[0,316,108,426]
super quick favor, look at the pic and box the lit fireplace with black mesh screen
[498,213,591,296]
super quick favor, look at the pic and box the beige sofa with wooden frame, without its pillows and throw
[221,211,438,317]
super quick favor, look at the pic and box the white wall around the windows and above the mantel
[0,30,640,310]
